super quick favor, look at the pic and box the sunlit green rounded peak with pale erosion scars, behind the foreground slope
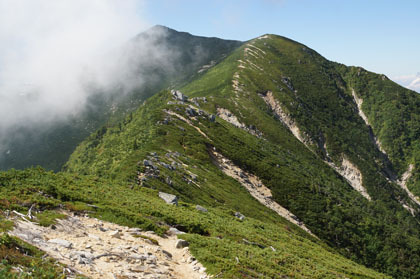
[66,35,420,278]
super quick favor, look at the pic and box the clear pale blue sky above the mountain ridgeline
[141,0,420,88]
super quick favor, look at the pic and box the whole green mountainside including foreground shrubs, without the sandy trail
[0,27,420,278]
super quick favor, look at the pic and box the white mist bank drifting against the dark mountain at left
[0,0,174,159]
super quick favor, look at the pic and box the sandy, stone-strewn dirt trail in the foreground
[10,213,210,279]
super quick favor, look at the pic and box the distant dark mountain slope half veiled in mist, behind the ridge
[0,25,241,171]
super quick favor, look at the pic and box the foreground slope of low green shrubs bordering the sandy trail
[0,169,388,278]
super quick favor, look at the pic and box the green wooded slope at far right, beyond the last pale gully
[340,67,420,201]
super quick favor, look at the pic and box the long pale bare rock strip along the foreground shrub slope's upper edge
[211,150,313,235]
